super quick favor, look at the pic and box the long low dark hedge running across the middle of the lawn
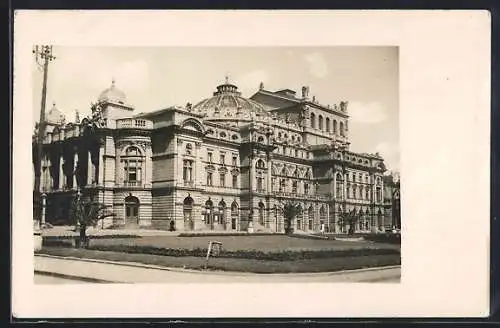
[88,244,400,261]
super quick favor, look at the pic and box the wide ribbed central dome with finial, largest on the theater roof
[192,79,271,121]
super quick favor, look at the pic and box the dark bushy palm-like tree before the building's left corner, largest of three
[70,194,114,248]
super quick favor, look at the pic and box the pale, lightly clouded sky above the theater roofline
[33,46,400,171]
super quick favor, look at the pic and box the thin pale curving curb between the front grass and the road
[35,254,401,276]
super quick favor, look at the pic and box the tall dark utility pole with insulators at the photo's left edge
[33,45,56,229]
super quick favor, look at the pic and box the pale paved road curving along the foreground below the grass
[35,256,401,283]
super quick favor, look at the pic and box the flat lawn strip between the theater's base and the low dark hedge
[83,236,399,252]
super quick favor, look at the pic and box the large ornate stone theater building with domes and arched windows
[34,79,386,232]
